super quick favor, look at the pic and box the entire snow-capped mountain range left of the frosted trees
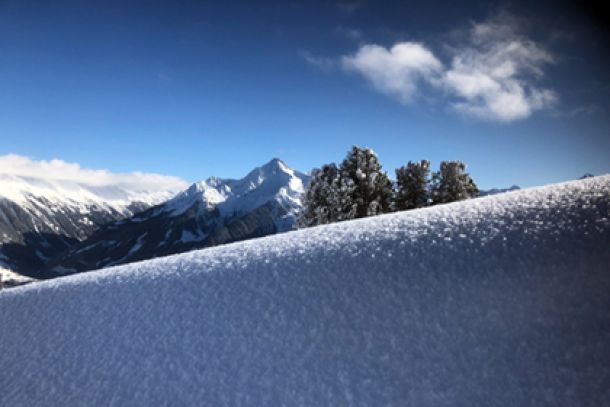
[0,159,309,278]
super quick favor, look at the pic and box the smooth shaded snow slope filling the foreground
[0,176,610,406]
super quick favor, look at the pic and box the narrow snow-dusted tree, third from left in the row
[394,160,430,211]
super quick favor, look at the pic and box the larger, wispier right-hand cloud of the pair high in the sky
[443,14,557,121]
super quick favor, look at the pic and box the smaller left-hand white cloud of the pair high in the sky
[341,42,442,103]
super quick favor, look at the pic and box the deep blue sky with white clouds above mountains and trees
[0,0,610,188]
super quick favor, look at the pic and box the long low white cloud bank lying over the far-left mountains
[0,154,188,191]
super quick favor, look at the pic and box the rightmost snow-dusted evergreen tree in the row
[431,161,479,204]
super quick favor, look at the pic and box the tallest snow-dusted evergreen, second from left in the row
[339,146,392,220]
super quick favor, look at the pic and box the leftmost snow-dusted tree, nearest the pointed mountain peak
[297,163,339,229]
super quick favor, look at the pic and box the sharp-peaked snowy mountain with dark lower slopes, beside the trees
[48,159,309,275]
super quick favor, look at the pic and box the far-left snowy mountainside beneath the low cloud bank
[0,173,183,277]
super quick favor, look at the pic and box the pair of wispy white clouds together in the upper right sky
[341,13,557,122]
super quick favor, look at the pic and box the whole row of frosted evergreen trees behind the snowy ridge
[297,146,479,228]
